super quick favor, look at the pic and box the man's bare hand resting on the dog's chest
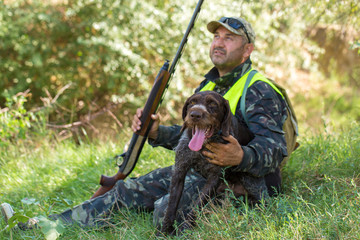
[202,135,244,167]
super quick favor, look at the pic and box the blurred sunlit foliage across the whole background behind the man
[0,0,360,133]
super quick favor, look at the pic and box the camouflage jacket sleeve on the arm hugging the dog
[234,81,287,176]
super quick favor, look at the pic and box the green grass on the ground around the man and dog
[0,124,360,239]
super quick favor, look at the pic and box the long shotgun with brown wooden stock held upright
[91,0,204,198]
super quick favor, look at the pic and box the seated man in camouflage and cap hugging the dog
[0,17,287,231]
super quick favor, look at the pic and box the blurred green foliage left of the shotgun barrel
[0,0,205,124]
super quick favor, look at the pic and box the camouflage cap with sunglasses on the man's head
[207,17,256,44]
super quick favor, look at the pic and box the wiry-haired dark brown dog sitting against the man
[161,91,267,234]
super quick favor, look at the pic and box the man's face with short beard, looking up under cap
[210,26,253,75]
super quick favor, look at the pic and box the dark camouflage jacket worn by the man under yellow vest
[149,59,287,176]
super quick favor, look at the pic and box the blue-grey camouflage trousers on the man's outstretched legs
[50,166,206,227]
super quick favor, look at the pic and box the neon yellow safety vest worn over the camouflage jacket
[200,68,284,115]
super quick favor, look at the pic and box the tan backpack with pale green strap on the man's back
[240,70,300,169]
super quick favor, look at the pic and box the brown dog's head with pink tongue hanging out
[182,91,232,151]
